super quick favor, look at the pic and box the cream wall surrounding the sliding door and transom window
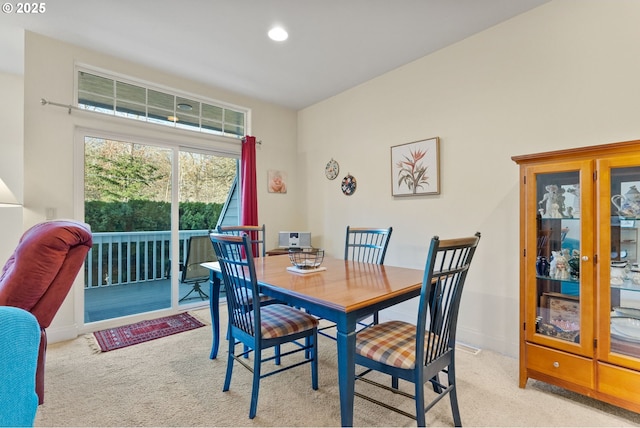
[24,32,303,342]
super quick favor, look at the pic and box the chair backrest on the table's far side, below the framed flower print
[344,226,393,265]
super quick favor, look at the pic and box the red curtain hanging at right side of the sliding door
[240,135,258,257]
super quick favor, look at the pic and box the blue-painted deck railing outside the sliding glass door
[85,230,209,288]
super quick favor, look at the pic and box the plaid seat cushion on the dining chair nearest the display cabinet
[356,321,440,369]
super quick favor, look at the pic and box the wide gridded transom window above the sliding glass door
[77,69,246,138]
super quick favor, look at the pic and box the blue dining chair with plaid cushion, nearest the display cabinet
[355,233,480,426]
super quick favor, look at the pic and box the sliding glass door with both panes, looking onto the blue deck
[84,136,237,324]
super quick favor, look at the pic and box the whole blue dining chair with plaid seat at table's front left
[210,233,318,419]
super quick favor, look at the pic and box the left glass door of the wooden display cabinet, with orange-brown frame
[527,161,593,355]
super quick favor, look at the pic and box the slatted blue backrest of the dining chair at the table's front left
[209,233,260,336]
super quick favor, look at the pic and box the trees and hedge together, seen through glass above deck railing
[85,137,238,232]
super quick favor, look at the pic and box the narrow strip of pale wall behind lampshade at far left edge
[0,73,24,267]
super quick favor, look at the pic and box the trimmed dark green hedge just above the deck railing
[85,199,223,232]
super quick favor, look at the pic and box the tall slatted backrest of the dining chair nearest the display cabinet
[415,233,480,366]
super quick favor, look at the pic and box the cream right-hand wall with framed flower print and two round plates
[298,0,640,356]
